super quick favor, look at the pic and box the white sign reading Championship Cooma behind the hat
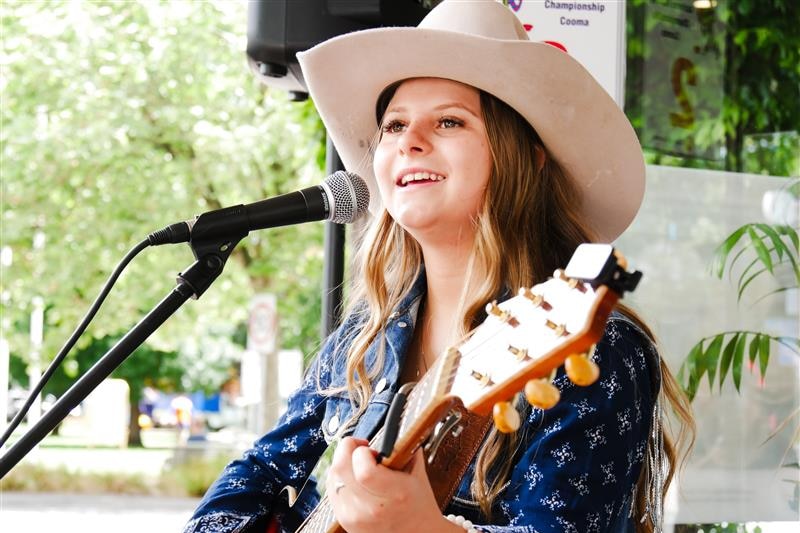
[508,0,625,107]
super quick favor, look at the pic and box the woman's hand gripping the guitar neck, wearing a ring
[326,437,464,533]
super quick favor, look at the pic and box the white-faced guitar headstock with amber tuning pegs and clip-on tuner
[439,244,641,431]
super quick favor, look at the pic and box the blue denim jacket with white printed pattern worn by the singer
[183,276,660,533]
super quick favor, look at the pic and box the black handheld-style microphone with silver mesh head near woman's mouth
[147,170,369,246]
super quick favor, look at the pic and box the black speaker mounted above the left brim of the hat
[247,0,438,100]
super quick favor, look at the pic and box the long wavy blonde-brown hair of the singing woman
[332,82,693,533]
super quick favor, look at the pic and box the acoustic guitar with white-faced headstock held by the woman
[278,244,642,533]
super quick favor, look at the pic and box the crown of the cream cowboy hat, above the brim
[419,0,529,41]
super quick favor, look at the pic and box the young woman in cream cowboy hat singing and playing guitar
[185,0,691,533]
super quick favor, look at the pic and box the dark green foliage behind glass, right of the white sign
[625,0,800,176]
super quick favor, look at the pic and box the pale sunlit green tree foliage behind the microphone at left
[0,1,324,444]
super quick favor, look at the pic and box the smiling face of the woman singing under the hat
[373,78,492,243]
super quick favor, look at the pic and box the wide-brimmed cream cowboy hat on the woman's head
[297,0,644,242]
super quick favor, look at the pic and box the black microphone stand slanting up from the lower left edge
[0,232,247,479]
